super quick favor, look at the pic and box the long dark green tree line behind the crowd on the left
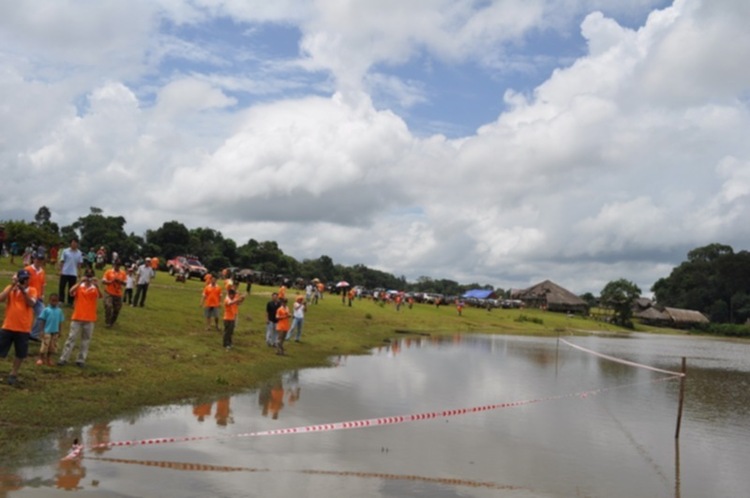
[1,206,503,295]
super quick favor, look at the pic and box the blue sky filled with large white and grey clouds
[0,0,750,295]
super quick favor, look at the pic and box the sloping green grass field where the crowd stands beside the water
[0,258,668,457]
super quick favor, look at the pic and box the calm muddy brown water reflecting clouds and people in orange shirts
[0,334,750,498]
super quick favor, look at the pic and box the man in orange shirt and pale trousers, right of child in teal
[57,268,102,368]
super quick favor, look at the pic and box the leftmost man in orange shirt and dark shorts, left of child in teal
[0,270,37,385]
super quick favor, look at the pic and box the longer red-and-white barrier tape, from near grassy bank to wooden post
[64,374,679,459]
